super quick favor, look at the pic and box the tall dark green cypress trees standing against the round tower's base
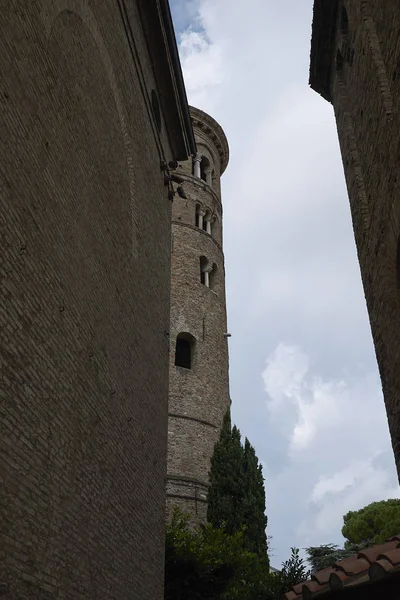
[207,411,267,558]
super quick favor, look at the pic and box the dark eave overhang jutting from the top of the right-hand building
[309,0,338,102]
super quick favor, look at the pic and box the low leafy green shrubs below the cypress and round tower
[164,510,308,600]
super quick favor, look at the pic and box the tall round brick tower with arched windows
[167,109,230,523]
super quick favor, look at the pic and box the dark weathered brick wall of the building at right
[312,0,400,474]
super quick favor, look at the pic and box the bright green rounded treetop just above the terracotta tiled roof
[342,500,400,548]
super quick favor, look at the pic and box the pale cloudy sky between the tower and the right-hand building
[171,0,400,567]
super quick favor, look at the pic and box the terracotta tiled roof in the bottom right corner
[281,535,400,600]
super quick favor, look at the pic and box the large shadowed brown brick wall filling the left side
[0,0,178,600]
